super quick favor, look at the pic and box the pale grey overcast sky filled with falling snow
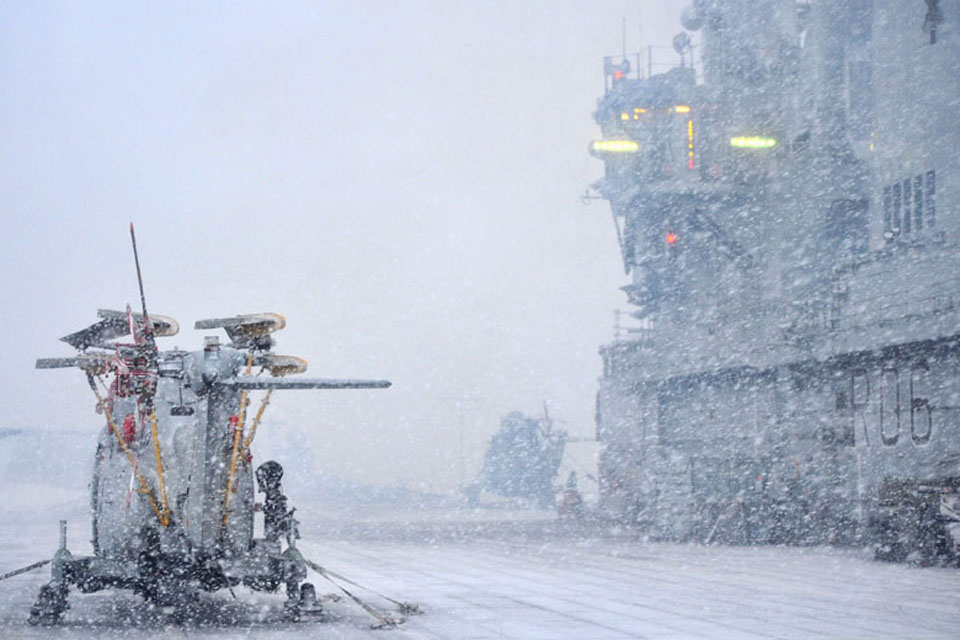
[0,0,683,489]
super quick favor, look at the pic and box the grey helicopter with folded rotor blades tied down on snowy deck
[30,224,390,624]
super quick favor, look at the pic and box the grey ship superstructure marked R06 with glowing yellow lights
[591,0,960,559]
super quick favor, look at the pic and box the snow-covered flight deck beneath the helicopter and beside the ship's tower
[0,498,960,640]
